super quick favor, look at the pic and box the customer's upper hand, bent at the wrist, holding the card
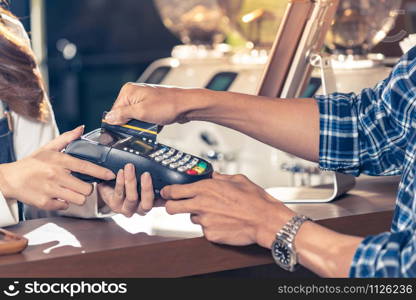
[106,83,201,125]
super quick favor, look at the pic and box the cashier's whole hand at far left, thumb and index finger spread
[0,126,115,210]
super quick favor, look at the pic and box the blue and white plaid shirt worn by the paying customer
[317,48,416,277]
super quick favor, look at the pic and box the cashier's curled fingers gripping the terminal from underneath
[97,164,155,217]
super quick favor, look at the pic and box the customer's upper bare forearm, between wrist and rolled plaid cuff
[187,90,319,161]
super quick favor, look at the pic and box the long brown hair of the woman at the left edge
[0,0,49,122]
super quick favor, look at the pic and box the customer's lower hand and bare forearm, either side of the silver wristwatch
[161,173,362,277]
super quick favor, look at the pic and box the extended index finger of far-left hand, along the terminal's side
[62,154,116,180]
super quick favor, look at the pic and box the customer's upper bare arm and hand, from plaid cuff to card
[106,83,319,162]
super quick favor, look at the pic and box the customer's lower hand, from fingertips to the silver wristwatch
[161,173,295,248]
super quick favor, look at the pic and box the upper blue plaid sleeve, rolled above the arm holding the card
[316,48,416,176]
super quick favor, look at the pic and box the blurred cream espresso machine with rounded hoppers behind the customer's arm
[138,0,401,192]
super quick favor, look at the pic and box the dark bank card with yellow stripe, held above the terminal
[101,112,163,142]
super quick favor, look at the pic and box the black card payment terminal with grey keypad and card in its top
[65,114,213,194]
